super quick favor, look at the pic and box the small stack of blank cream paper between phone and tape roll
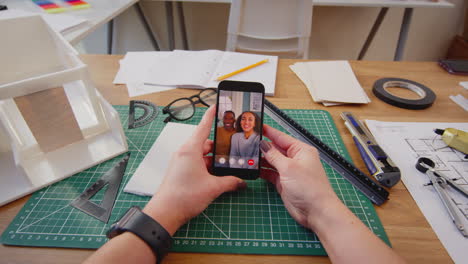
[289,61,370,106]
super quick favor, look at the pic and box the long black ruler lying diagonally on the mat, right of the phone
[265,100,389,205]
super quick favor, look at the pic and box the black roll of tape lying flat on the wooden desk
[372,78,436,110]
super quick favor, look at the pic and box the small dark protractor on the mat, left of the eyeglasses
[128,100,159,129]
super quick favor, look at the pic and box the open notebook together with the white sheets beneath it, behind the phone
[114,50,278,97]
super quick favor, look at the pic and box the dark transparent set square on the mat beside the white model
[70,152,130,223]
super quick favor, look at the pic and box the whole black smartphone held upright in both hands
[212,81,265,180]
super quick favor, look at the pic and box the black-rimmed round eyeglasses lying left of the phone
[163,88,217,123]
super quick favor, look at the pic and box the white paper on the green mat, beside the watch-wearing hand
[124,122,197,196]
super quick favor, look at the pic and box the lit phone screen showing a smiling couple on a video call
[215,90,262,169]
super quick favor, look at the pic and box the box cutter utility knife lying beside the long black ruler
[341,112,401,187]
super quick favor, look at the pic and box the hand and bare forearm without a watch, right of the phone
[260,125,405,264]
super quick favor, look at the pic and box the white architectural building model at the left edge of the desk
[0,15,128,206]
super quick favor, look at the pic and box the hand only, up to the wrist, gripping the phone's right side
[260,125,340,229]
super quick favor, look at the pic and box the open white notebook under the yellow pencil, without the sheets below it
[144,50,278,96]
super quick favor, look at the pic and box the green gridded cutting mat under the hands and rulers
[1,106,390,255]
